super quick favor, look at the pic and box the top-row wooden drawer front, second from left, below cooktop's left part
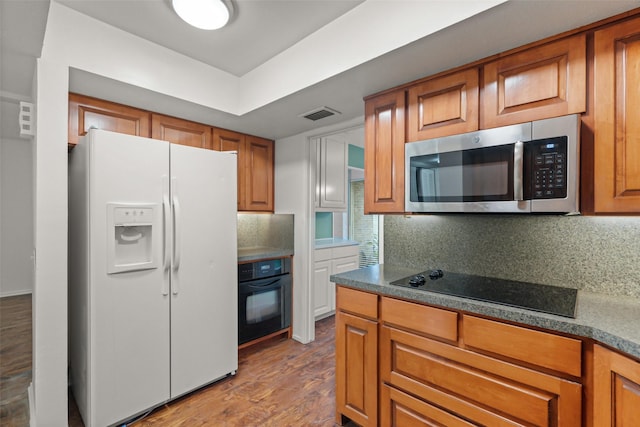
[380,297,458,341]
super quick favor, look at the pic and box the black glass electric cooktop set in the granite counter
[391,270,578,318]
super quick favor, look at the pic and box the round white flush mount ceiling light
[171,0,231,30]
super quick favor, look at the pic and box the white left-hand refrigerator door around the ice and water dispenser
[90,131,169,426]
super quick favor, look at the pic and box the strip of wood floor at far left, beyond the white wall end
[0,294,32,427]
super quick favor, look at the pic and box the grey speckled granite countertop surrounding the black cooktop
[331,264,640,358]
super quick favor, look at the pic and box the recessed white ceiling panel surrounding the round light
[58,0,370,77]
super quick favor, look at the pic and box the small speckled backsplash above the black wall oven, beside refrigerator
[238,214,293,251]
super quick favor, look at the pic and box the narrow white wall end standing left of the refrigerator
[31,59,69,427]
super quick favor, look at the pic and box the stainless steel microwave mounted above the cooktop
[405,114,580,213]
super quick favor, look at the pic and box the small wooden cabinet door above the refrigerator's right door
[151,113,212,149]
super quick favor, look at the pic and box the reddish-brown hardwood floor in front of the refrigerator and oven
[69,317,350,427]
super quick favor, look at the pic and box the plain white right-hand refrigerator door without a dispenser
[171,144,238,398]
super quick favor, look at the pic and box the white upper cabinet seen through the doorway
[315,136,349,211]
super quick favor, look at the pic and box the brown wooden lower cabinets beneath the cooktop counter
[336,285,640,427]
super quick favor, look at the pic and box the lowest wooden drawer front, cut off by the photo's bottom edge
[380,384,475,427]
